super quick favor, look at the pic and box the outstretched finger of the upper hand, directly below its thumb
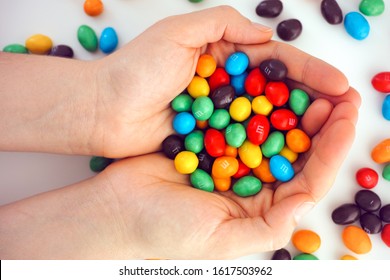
[238,41,349,96]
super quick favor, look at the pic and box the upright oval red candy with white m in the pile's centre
[246,115,270,145]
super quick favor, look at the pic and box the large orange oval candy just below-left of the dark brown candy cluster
[342,225,372,254]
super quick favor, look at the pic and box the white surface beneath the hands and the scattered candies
[0,0,390,260]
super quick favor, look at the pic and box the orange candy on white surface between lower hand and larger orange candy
[291,229,321,254]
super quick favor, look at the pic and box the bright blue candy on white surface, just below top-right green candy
[344,12,370,40]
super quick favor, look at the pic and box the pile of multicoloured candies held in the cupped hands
[163,52,311,197]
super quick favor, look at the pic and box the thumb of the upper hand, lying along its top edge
[155,6,273,48]
